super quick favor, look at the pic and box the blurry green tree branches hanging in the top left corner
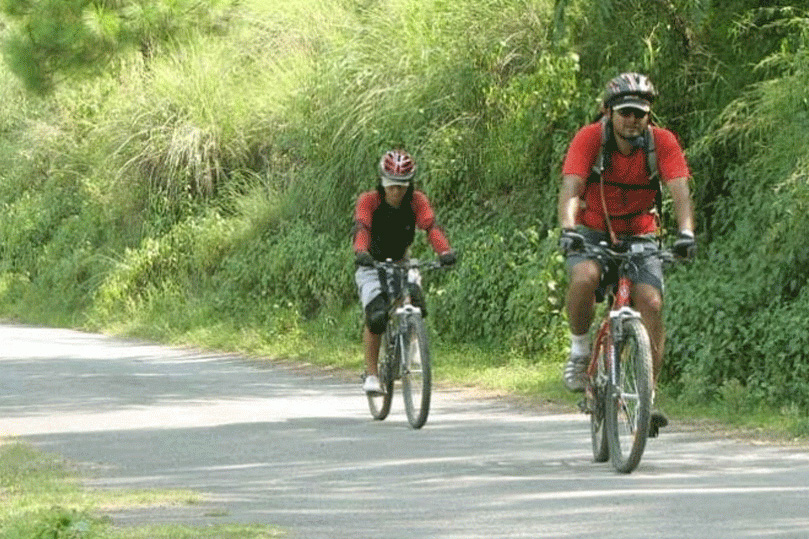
[0,0,230,94]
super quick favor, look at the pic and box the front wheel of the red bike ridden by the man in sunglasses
[606,318,653,473]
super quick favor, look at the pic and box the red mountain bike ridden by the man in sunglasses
[583,243,675,473]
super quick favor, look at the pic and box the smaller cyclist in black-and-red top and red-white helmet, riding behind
[354,150,456,393]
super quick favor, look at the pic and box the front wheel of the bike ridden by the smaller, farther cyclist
[402,314,432,429]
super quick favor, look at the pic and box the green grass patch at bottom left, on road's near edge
[0,439,284,539]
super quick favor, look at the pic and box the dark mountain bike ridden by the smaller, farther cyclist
[368,259,443,429]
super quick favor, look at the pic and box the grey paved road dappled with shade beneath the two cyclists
[0,325,809,539]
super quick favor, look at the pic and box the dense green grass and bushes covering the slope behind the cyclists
[0,0,809,418]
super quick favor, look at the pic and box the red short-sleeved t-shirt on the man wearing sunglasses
[562,122,691,234]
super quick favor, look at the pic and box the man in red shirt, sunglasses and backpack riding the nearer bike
[558,73,696,426]
